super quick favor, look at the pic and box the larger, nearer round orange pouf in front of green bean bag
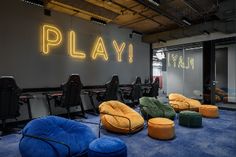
[148,118,175,140]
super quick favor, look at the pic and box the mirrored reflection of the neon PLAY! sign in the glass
[167,53,194,70]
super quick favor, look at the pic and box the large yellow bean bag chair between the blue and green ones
[99,100,144,134]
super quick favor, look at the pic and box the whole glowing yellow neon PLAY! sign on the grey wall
[42,25,133,63]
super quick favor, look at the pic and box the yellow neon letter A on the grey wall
[92,37,108,61]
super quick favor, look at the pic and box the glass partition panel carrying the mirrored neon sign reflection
[153,43,203,99]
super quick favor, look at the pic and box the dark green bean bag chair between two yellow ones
[139,97,176,120]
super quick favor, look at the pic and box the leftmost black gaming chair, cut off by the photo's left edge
[0,76,21,132]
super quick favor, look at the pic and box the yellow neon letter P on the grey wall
[42,25,62,54]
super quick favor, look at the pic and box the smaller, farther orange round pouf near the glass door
[199,105,219,118]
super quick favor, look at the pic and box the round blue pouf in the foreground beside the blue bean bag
[88,136,127,157]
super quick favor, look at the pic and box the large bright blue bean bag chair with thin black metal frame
[19,116,96,157]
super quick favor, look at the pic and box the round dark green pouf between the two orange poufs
[179,111,202,128]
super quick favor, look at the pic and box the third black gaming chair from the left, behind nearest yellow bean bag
[97,75,119,101]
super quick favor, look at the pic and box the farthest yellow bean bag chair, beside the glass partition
[169,93,201,112]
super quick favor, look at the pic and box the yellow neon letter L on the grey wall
[69,31,86,59]
